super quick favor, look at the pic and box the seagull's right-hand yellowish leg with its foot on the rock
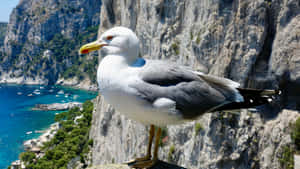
[129,128,161,169]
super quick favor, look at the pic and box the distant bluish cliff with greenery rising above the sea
[0,0,101,88]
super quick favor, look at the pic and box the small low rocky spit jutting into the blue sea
[32,102,82,111]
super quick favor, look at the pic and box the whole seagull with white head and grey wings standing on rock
[79,27,279,168]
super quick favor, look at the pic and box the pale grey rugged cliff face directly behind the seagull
[91,0,300,169]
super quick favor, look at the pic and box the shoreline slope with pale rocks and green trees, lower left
[9,100,94,169]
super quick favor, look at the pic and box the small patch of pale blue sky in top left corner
[0,0,19,22]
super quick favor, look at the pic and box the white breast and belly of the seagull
[97,55,183,126]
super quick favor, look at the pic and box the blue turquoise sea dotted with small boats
[0,84,97,169]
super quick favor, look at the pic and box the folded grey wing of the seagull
[131,60,241,119]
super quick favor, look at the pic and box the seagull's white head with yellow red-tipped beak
[79,27,139,63]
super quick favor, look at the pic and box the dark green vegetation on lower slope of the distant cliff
[4,26,98,84]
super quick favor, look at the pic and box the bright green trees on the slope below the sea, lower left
[20,101,93,169]
